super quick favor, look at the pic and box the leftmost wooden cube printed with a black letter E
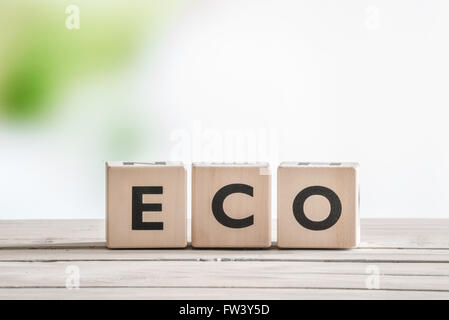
[106,161,187,248]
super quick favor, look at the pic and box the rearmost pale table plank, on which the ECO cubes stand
[0,219,449,249]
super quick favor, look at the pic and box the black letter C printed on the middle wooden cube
[212,183,254,229]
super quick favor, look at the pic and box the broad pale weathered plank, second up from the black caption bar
[0,261,449,292]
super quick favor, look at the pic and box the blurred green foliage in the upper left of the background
[0,0,186,158]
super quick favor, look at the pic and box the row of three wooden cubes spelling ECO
[106,161,359,248]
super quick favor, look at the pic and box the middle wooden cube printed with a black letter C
[192,163,271,248]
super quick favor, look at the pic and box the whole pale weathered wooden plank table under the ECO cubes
[0,219,449,299]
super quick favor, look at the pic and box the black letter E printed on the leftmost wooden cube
[132,187,164,230]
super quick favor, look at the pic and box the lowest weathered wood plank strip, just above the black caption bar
[0,288,449,300]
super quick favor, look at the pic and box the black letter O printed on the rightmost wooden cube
[293,186,341,231]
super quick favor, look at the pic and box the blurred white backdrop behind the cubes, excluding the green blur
[0,0,449,219]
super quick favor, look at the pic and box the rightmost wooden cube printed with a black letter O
[277,162,360,248]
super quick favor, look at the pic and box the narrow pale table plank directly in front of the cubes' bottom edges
[0,248,449,263]
